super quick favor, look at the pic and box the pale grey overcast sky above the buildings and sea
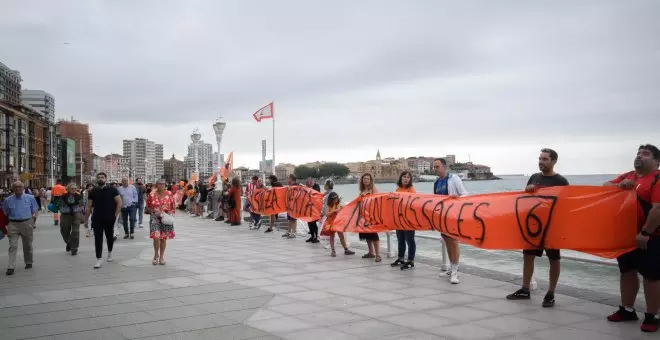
[0,0,660,174]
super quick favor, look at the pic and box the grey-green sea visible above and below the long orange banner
[328,174,619,295]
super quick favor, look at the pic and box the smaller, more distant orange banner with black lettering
[248,185,323,222]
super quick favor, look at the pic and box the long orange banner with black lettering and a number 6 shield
[329,186,637,258]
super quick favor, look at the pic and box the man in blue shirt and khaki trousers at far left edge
[2,181,37,275]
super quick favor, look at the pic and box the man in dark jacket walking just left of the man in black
[59,182,84,256]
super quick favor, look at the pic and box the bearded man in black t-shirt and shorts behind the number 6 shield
[506,149,568,307]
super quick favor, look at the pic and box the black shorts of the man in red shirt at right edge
[616,236,660,281]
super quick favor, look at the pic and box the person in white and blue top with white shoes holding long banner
[433,158,468,284]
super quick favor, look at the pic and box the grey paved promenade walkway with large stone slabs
[0,216,653,340]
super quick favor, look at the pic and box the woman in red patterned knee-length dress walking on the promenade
[147,179,176,266]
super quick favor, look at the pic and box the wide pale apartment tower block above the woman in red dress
[123,138,165,183]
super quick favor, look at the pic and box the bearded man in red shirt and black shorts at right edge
[605,144,660,332]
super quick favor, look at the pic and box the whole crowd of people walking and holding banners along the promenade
[0,144,660,332]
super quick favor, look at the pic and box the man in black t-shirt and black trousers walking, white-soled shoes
[85,172,122,269]
